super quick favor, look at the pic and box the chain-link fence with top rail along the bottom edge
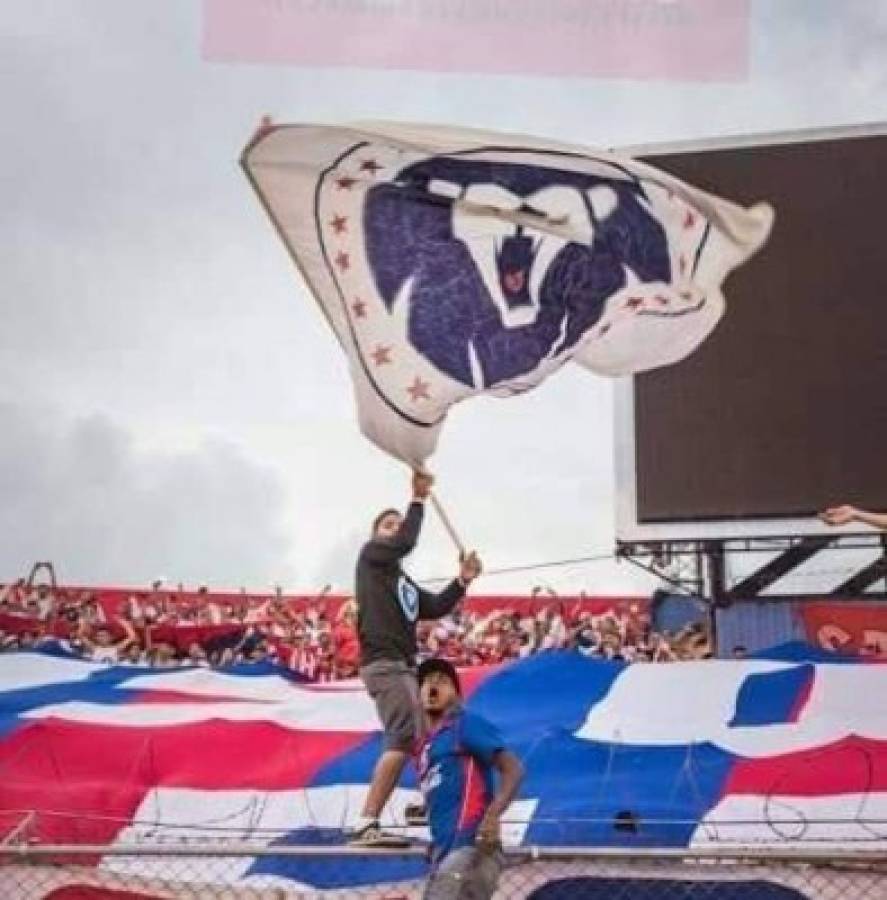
[0,842,887,900]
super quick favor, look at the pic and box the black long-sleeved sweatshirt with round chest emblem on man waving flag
[355,502,465,666]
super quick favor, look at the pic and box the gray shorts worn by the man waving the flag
[360,659,425,753]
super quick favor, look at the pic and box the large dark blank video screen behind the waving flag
[633,135,887,523]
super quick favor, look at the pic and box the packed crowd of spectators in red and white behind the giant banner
[0,579,711,681]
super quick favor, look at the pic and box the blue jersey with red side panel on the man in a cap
[418,709,505,859]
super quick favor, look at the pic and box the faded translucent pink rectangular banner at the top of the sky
[203,0,750,81]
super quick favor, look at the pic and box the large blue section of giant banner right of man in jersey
[468,651,736,847]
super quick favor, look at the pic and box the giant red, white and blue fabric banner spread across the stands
[0,652,887,896]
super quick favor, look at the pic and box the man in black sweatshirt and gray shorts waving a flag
[351,472,481,847]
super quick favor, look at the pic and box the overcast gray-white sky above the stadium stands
[0,0,887,593]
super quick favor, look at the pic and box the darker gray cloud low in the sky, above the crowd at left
[0,403,294,588]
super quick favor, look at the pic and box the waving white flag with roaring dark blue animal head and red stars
[243,125,773,465]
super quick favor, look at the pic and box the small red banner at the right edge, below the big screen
[798,601,887,659]
